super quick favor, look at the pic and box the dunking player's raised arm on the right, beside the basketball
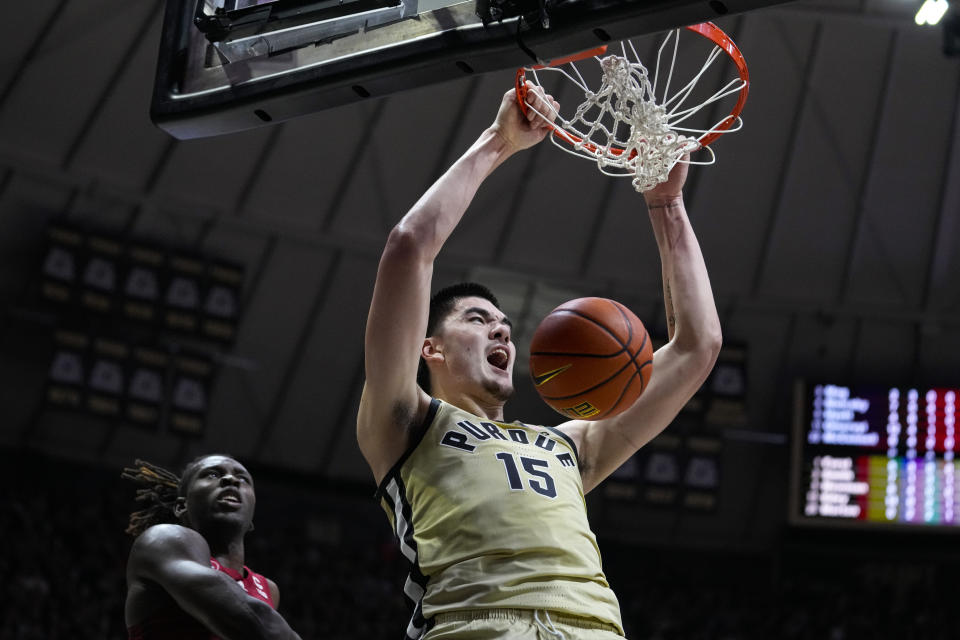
[562,163,722,491]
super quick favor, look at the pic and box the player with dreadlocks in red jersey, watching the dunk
[122,455,300,640]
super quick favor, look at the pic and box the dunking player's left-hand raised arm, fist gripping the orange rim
[357,90,549,482]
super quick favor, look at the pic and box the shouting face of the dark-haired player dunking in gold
[439,297,516,400]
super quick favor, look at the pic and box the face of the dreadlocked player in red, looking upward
[180,456,257,533]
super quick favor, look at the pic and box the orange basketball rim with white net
[516,22,750,192]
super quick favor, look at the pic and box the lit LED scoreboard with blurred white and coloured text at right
[790,383,960,528]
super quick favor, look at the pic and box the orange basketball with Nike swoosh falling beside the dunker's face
[530,298,653,420]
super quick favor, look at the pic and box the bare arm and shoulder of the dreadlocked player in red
[127,525,300,640]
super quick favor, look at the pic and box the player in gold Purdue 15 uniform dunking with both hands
[357,85,721,640]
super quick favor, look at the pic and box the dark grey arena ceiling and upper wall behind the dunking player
[0,0,960,544]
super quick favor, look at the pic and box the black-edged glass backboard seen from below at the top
[151,0,785,139]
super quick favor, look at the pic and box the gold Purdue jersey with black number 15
[377,399,623,638]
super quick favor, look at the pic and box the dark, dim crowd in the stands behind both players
[0,455,960,640]
